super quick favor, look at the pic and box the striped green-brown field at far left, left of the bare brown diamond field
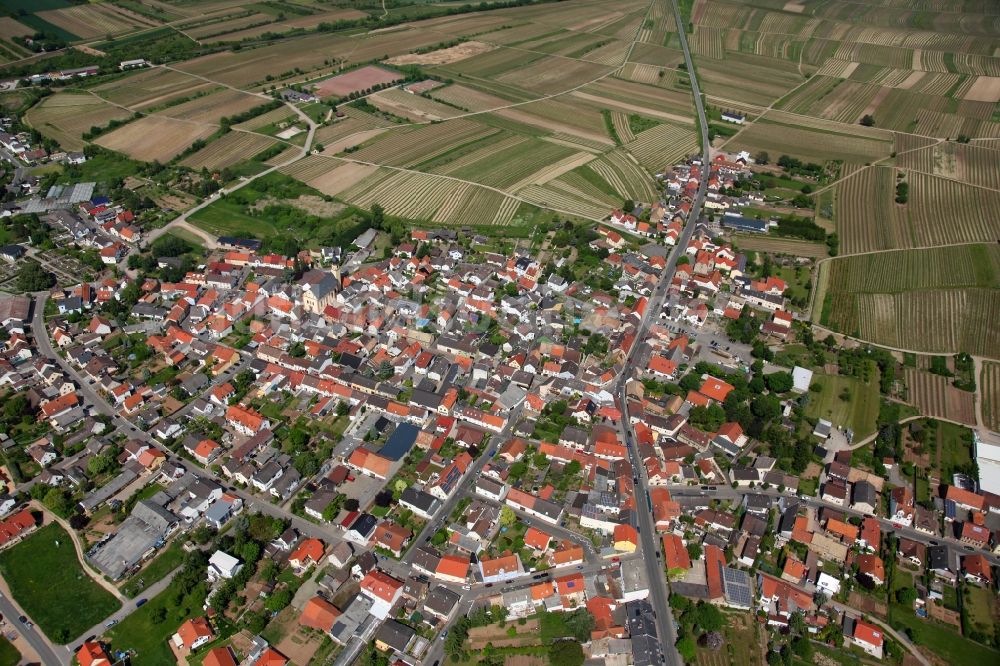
[25,93,131,150]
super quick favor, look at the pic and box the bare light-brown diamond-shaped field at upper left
[95,116,216,163]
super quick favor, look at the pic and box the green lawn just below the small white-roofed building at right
[806,373,879,440]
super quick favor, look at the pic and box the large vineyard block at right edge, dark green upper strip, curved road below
[814,245,1000,358]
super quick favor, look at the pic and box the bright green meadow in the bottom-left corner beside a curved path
[0,523,121,643]
